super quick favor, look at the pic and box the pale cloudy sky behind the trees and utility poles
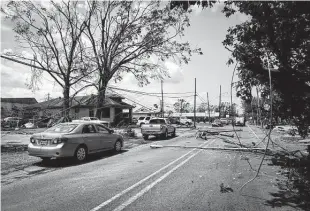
[1,2,246,112]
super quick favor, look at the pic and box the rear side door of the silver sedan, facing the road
[82,124,102,153]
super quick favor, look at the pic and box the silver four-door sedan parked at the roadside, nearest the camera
[28,122,124,162]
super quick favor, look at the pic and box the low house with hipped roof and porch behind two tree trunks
[25,94,133,124]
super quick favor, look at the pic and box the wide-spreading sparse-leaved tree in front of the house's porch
[85,1,202,118]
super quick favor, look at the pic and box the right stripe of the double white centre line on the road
[113,140,215,211]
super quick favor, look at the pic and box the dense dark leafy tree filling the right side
[223,1,310,136]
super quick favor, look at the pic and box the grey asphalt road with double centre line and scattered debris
[1,128,291,211]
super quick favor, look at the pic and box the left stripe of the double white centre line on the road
[90,138,212,211]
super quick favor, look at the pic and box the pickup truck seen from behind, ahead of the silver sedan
[141,118,176,140]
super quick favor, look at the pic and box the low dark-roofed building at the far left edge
[1,98,38,118]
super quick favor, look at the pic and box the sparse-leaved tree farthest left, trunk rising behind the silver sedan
[1,1,94,116]
